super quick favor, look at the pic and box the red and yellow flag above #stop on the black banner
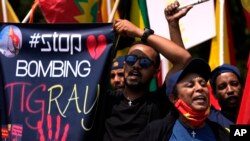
[39,0,98,23]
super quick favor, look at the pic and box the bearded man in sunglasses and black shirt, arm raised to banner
[99,19,191,141]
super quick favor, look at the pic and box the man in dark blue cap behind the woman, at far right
[209,64,243,129]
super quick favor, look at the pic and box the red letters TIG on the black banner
[5,82,46,129]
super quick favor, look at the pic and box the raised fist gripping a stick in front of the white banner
[164,1,193,23]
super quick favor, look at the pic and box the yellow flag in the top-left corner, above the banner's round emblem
[0,1,19,23]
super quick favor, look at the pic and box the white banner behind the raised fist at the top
[147,0,215,49]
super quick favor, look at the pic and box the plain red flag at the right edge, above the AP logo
[237,54,250,124]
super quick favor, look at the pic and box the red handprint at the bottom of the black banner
[37,114,69,141]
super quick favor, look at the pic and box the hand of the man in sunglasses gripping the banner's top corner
[113,19,144,37]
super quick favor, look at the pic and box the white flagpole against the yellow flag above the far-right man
[219,0,225,65]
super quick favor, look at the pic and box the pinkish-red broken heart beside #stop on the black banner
[87,34,107,60]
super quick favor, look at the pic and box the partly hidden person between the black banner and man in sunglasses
[110,56,125,90]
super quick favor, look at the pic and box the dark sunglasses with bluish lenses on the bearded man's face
[125,55,154,69]
